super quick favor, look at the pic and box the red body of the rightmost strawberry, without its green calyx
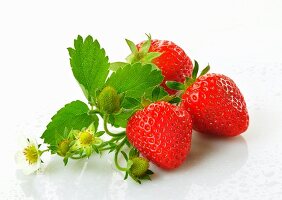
[181,74,249,137]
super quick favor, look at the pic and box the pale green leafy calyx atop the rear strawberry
[125,34,162,64]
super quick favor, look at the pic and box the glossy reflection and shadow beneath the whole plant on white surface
[12,133,248,199]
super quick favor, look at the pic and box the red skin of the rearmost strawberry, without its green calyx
[137,40,193,94]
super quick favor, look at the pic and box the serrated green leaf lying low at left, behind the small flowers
[41,101,98,151]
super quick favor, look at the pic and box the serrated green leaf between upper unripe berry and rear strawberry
[106,63,163,99]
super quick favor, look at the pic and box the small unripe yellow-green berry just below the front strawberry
[130,157,149,178]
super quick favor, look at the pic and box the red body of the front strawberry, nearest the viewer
[126,101,192,169]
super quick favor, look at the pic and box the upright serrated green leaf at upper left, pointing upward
[68,36,110,103]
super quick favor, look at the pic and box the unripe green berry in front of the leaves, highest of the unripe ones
[97,86,121,114]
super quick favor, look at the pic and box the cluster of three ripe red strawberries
[126,35,249,169]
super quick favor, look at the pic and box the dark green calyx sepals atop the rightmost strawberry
[166,60,210,91]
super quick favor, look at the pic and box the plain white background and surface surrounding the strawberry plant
[0,0,282,200]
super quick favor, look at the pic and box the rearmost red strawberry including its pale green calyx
[127,36,193,94]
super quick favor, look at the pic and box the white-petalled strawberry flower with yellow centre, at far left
[15,138,42,175]
